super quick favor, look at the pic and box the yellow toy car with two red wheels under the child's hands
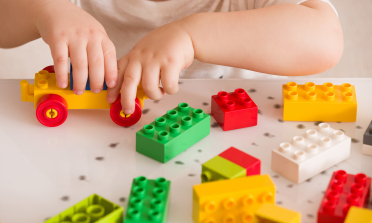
[20,66,147,127]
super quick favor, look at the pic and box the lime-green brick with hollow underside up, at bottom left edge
[45,194,123,223]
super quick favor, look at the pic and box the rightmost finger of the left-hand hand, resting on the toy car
[102,38,118,88]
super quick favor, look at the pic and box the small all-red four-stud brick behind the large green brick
[211,88,258,131]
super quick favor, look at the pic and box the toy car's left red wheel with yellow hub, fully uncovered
[36,94,68,127]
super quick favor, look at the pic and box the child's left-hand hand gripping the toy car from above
[35,1,117,95]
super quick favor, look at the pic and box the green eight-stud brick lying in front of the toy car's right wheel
[136,103,211,163]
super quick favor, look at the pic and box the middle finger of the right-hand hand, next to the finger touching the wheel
[142,65,164,100]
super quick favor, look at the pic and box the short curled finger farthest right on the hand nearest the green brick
[161,65,180,94]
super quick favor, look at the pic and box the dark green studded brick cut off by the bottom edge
[124,176,170,223]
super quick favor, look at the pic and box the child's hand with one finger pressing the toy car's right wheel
[107,21,194,114]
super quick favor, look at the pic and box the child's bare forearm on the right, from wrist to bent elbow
[180,1,343,76]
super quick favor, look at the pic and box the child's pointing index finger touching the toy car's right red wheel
[121,61,142,114]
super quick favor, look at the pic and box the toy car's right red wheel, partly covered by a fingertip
[110,96,142,127]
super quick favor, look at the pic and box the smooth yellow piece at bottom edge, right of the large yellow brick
[255,203,301,223]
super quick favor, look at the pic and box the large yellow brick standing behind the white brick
[283,82,357,122]
